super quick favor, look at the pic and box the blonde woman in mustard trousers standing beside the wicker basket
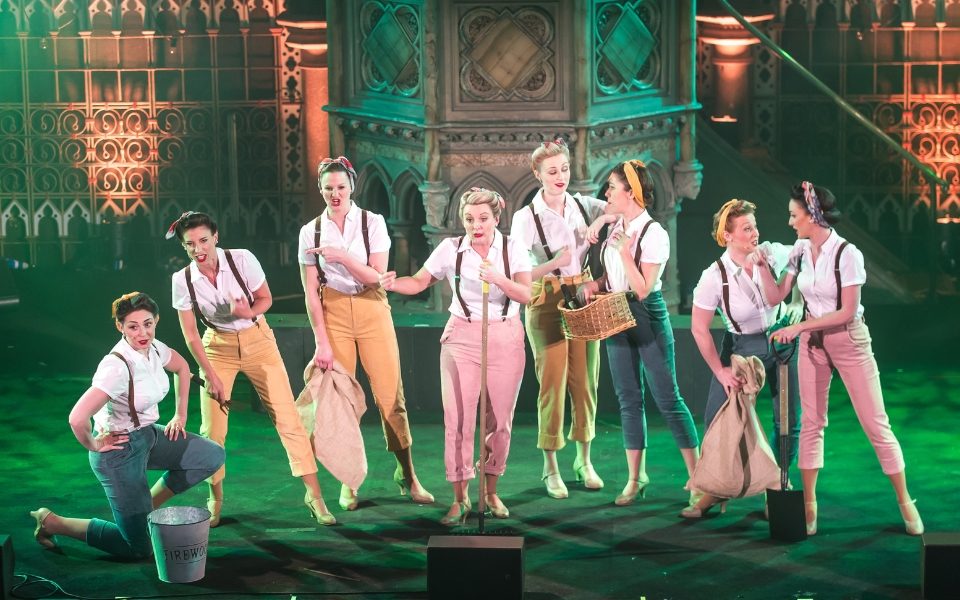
[510,138,606,498]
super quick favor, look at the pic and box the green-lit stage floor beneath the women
[0,369,960,600]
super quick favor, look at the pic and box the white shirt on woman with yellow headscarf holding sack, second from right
[693,242,791,334]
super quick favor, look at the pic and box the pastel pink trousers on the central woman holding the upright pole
[440,314,526,482]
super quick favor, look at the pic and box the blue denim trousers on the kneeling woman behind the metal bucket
[87,425,224,558]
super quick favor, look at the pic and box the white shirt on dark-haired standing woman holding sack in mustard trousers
[297,204,390,295]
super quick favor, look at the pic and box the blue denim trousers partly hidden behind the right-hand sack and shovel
[703,332,800,466]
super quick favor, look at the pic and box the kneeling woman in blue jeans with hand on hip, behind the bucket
[30,292,224,558]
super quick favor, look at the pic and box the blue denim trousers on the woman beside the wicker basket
[606,292,700,450]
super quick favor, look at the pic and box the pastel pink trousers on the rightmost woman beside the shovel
[797,319,904,475]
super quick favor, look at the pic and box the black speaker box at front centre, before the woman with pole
[427,535,523,600]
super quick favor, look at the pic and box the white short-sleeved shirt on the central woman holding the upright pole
[423,230,532,319]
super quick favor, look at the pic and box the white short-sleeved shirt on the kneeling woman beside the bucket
[93,338,172,432]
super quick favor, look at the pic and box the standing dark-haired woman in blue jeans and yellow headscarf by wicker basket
[582,160,700,506]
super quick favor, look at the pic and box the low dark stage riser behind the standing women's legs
[267,313,723,421]
